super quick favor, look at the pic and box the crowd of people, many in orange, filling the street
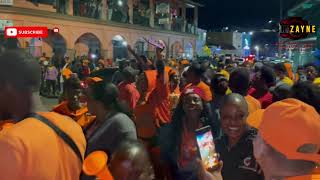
[0,46,320,180]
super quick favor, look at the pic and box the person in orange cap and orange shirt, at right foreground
[253,99,320,180]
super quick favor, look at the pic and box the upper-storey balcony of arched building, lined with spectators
[0,0,197,35]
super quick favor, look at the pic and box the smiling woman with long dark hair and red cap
[159,87,219,180]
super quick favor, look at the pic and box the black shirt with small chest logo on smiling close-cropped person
[216,129,264,180]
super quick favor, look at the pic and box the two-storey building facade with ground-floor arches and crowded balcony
[0,0,201,59]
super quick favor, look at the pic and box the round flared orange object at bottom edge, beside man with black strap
[82,151,113,180]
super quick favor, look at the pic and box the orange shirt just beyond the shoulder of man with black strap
[52,101,96,128]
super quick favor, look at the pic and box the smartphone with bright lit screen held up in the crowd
[196,126,219,169]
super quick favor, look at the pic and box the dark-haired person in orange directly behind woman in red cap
[186,62,212,102]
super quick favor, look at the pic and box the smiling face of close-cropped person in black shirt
[220,103,248,140]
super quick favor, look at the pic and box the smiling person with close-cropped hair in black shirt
[216,93,264,180]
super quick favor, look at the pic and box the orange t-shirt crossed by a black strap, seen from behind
[0,112,86,180]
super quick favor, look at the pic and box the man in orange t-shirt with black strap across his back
[0,51,86,180]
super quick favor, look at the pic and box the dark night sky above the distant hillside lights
[199,0,301,30]
